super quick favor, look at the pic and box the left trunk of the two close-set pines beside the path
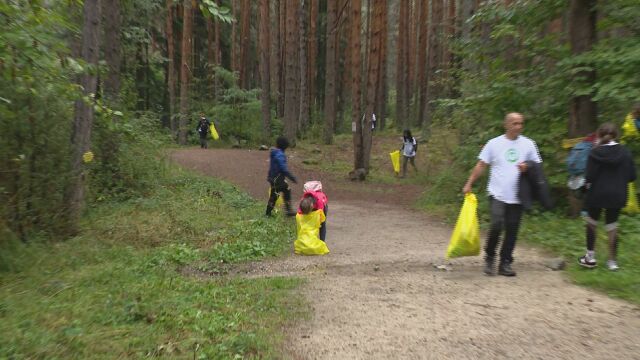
[349,0,364,170]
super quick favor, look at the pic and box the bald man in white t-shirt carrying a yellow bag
[462,113,542,276]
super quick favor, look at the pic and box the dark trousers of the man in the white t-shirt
[485,197,522,264]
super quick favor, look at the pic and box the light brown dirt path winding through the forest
[172,150,640,359]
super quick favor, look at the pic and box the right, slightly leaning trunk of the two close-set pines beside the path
[362,1,386,172]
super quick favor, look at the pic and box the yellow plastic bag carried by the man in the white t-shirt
[447,193,480,259]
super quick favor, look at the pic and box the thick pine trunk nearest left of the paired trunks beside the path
[324,1,338,144]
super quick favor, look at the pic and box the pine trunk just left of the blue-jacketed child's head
[259,0,271,142]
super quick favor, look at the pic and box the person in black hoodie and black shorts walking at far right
[578,123,636,271]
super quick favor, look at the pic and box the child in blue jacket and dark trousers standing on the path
[266,136,298,216]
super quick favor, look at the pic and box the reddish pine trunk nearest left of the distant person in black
[178,0,193,145]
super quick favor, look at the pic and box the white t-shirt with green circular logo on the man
[478,135,542,204]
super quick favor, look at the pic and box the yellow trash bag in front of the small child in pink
[293,210,329,255]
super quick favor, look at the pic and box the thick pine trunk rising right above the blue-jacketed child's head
[284,3,299,143]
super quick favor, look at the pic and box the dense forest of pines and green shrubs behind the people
[0,0,640,240]
